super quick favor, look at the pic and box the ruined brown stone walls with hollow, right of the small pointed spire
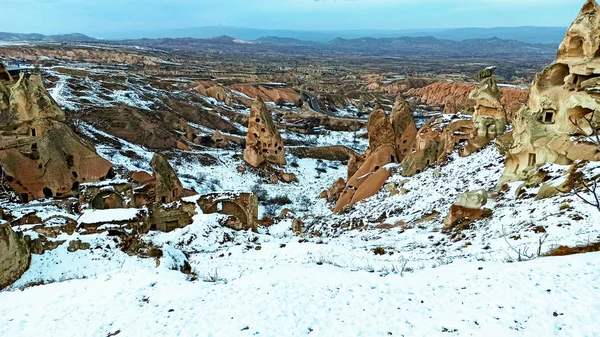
[198,192,258,232]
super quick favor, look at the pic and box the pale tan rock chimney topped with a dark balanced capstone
[469,67,507,139]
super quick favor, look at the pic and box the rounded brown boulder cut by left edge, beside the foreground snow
[0,223,31,290]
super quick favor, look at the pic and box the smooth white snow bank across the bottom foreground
[0,248,600,337]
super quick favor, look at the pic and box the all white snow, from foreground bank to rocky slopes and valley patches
[0,58,600,337]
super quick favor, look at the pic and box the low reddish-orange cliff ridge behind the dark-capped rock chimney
[404,82,529,118]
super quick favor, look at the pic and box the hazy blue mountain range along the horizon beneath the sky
[90,25,567,45]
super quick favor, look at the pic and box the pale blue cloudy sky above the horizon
[0,0,584,36]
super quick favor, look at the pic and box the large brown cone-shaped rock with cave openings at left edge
[0,68,114,201]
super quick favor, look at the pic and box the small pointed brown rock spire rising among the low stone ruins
[150,153,183,204]
